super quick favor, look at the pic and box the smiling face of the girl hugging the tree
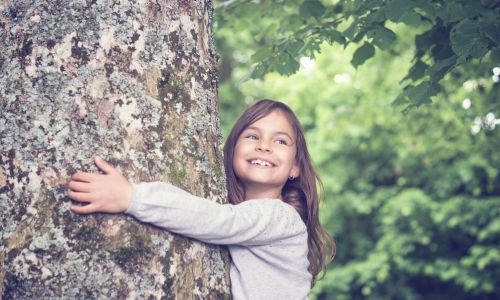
[233,109,299,197]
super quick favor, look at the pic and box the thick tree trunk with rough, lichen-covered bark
[0,0,230,299]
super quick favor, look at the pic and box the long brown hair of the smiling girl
[224,99,335,284]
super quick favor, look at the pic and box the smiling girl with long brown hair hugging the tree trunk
[69,100,335,300]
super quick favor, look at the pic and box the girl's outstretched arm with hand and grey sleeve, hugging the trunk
[69,158,306,245]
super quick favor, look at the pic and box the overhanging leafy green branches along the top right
[218,0,500,111]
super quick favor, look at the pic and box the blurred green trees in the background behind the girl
[214,0,500,299]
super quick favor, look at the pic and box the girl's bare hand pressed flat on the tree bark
[68,156,132,214]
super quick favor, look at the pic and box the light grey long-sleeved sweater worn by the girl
[126,182,312,300]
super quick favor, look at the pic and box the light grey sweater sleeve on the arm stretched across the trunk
[126,182,306,246]
